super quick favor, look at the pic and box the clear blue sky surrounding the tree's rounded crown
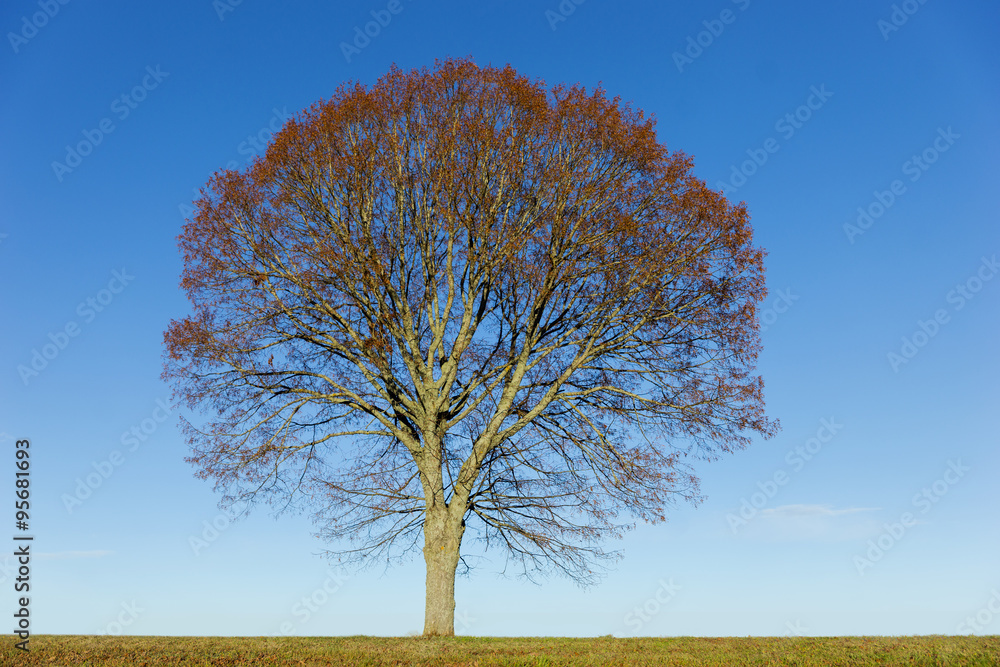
[0,0,1000,636]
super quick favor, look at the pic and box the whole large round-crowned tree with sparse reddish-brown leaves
[164,60,776,635]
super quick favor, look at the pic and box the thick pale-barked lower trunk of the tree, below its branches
[424,511,465,637]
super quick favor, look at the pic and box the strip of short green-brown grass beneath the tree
[0,635,1000,667]
